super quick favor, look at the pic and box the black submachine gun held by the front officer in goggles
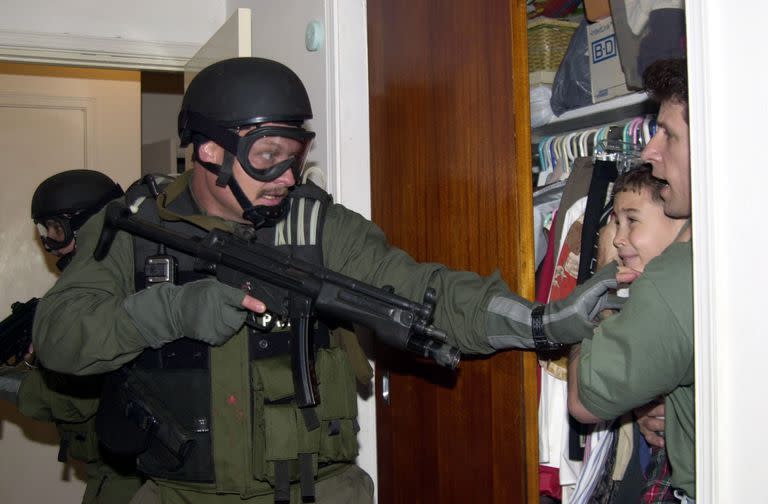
[94,201,460,424]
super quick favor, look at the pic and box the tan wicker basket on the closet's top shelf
[528,17,579,73]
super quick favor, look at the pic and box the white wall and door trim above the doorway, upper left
[0,0,225,70]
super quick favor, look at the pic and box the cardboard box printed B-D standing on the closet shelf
[587,17,630,103]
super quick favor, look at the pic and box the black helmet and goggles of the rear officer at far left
[32,170,123,252]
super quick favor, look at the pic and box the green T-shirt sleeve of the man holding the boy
[578,243,694,420]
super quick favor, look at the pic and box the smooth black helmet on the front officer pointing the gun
[179,58,312,147]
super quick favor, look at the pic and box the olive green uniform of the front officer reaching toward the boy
[34,172,508,502]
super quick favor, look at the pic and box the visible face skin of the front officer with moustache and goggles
[193,122,304,222]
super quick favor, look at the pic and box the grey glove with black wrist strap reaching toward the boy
[485,263,625,350]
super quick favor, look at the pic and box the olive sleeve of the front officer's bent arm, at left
[32,207,147,374]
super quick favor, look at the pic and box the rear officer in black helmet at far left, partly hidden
[0,170,142,504]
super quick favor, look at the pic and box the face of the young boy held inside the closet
[613,188,685,271]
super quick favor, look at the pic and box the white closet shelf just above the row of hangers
[531,92,658,142]
